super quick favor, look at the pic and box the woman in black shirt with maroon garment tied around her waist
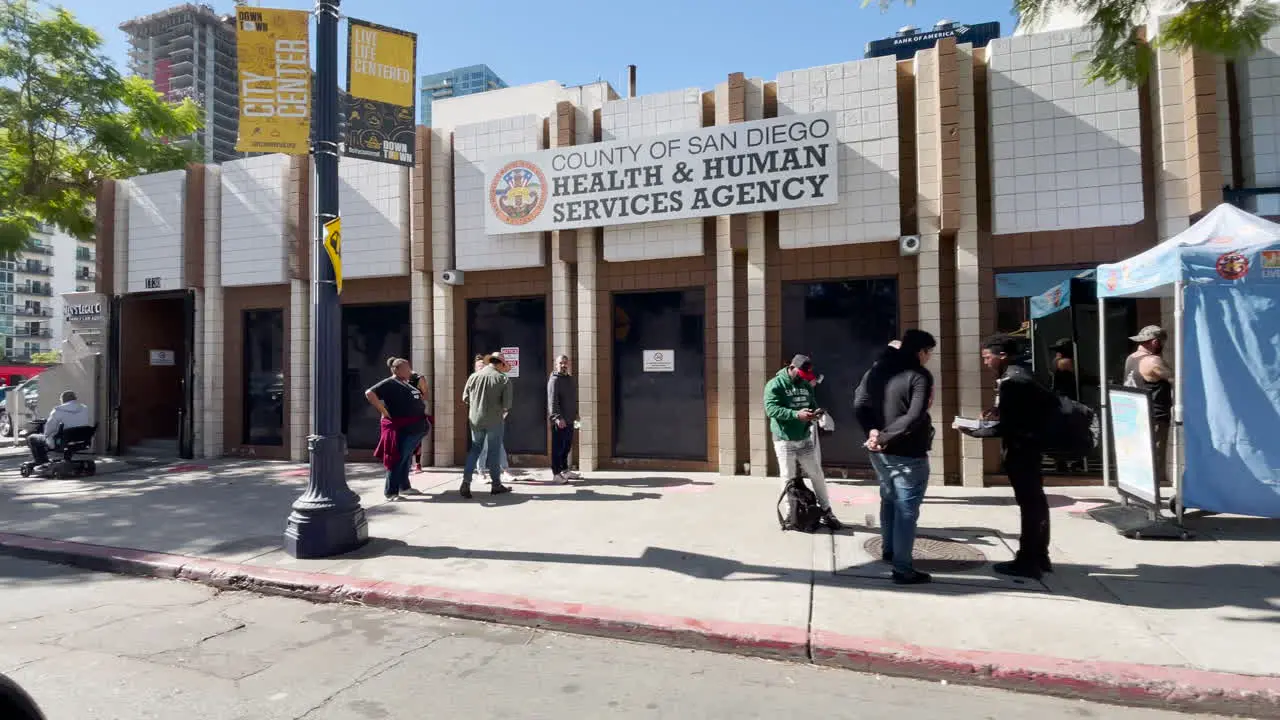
[365,357,430,501]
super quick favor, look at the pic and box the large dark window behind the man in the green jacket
[771,278,899,466]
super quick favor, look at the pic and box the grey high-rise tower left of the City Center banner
[120,4,242,163]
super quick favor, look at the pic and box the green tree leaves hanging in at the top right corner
[863,0,1280,85]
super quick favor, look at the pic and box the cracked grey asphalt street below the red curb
[0,557,1223,720]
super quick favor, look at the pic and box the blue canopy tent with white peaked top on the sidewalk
[1097,205,1280,521]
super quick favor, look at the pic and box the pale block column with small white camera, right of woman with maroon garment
[430,129,455,468]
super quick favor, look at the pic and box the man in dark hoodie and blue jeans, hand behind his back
[854,329,937,585]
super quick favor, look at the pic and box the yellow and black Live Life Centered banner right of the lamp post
[343,18,417,167]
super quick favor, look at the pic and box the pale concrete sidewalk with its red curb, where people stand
[0,461,1280,717]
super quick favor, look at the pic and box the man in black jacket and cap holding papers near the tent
[961,334,1056,579]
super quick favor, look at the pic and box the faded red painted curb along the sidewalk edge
[0,533,1280,720]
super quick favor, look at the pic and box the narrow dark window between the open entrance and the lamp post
[242,310,284,446]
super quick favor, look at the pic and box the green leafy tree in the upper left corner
[0,0,201,251]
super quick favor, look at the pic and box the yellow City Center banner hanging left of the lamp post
[236,5,311,155]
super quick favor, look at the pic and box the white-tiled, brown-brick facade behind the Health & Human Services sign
[97,19,1280,486]
